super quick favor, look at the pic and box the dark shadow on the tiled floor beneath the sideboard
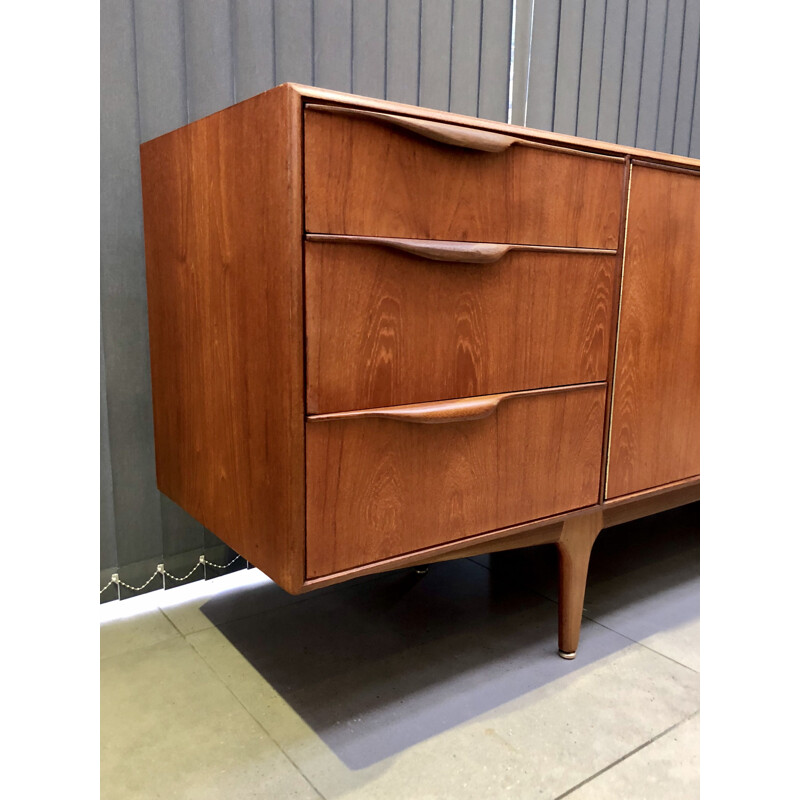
[202,504,699,769]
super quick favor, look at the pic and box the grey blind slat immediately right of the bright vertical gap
[525,0,561,131]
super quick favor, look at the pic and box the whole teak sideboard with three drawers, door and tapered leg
[141,84,700,658]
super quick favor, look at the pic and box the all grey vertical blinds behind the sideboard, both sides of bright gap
[100,0,699,599]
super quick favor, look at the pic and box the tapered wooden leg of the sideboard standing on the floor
[556,511,603,658]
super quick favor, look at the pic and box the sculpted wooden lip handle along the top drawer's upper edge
[305,101,625,163]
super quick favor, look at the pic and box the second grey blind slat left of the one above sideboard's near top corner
[183,0,235,121]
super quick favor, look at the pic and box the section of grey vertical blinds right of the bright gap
[512,0,700,158]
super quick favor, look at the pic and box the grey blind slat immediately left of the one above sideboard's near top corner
[232,0,275,100]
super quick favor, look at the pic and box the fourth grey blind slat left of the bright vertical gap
[386,0,420,104]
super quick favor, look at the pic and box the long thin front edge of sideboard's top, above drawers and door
[290,82,700,168]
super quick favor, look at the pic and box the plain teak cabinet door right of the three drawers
[606,165,700,498]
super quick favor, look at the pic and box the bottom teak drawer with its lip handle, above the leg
[306,384,605,578]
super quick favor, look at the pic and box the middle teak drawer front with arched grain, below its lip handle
[305,241,615,414]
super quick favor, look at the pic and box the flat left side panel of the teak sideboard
[141,86,305,591]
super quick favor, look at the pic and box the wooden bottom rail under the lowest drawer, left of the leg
[299,506,597,593]
